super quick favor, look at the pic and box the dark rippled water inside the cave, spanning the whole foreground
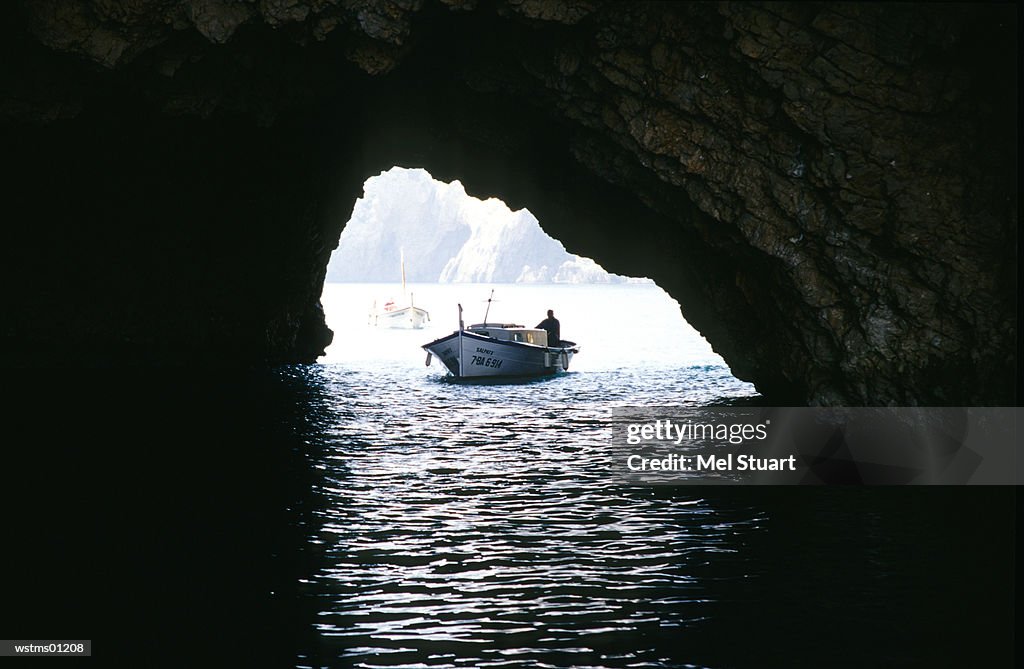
[0,366,1015,667]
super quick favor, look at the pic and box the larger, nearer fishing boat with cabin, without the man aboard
[415,290,580,378]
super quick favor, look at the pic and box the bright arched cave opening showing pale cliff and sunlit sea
[321,167,731,377]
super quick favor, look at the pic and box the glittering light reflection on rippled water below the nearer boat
[298,360,762,667]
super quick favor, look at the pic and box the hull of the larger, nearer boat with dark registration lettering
[423,331,579,378]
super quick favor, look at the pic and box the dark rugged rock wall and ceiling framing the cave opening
[0,0,1017,404]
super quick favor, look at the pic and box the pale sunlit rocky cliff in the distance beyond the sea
[327,167,628,284]
